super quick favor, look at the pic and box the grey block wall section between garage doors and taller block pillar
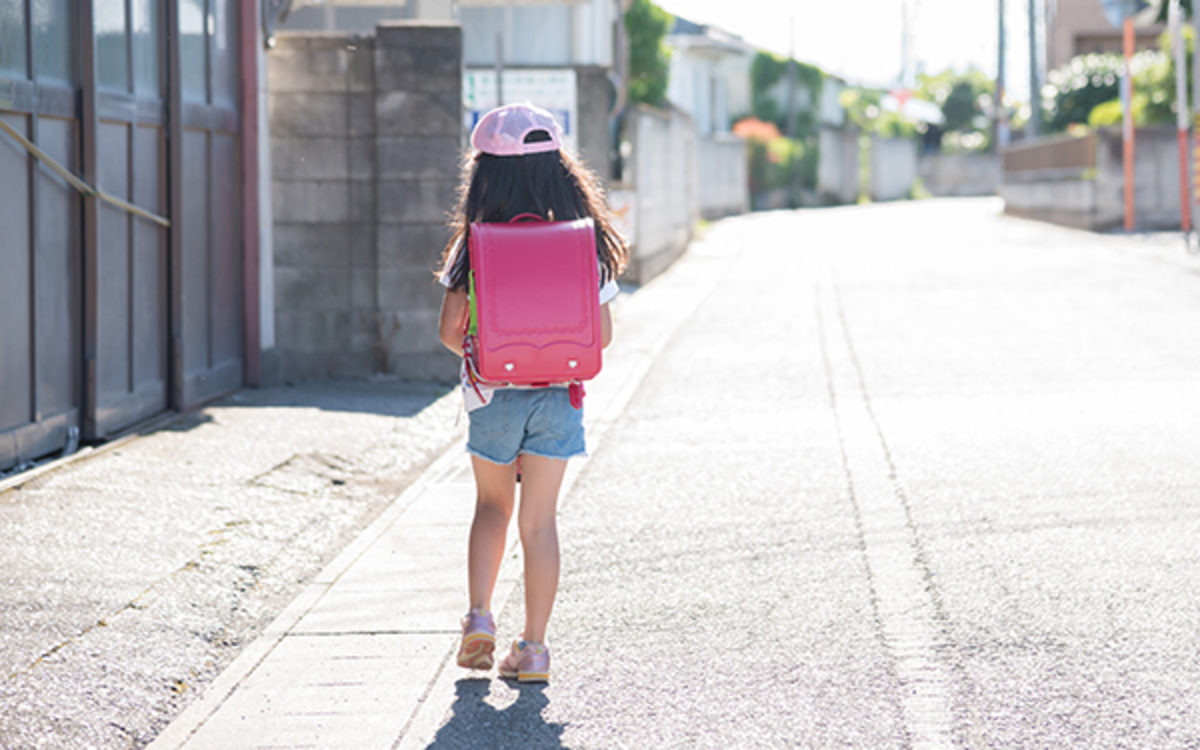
[268,34,377,379]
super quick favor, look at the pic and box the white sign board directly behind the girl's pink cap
[462,67,578,152]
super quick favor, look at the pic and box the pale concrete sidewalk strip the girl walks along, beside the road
[141,220,748,750]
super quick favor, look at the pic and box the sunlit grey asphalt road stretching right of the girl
[433,200,1200,749]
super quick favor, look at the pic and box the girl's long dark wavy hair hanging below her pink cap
[438,131,629,289]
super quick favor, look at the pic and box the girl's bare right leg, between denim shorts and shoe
[518,454,566,643]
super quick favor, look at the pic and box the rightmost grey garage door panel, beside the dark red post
[170,0,244,408]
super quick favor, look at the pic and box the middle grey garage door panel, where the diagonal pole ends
[83,0,168,438]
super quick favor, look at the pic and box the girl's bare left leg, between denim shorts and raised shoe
[467,456,517,610]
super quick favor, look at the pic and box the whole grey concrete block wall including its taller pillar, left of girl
[268,22,462,380]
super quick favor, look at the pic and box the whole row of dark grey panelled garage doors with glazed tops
[0,0,244,470]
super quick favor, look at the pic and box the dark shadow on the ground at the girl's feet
[427,678,566,750]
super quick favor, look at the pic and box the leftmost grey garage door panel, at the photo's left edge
[0,0,82,470]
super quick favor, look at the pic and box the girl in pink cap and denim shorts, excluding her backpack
[439,103,628,683]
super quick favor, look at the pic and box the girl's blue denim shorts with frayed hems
[467,388,587,464]
